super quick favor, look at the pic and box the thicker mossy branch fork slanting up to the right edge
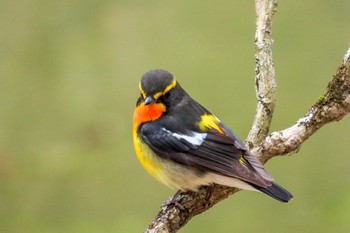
[252,47,350,162]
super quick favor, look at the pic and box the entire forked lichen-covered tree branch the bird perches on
[145,0,350,233]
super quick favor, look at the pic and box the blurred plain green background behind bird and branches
[0,0,350,233]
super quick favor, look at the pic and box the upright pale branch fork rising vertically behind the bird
[247,0,277,149]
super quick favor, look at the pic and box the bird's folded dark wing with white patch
[140,122,272,187]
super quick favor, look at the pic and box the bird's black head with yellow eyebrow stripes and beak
[140,69,177,104]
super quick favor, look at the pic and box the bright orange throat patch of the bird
[133,103,166,127]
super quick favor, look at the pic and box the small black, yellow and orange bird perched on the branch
[133,69,293,202]
